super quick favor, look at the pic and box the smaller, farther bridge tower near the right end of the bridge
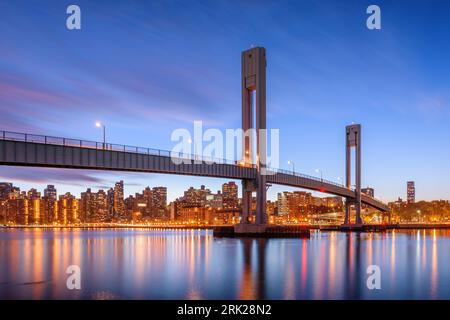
[344,124,362,225]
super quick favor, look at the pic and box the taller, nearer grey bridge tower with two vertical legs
[241,47,267,224]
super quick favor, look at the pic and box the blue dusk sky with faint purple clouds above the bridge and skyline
[0,0,450,201]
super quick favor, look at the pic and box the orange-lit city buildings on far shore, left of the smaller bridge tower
[0,180,343,225]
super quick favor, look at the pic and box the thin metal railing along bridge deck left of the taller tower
[0,130,255,168]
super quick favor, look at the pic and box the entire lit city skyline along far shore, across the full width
[0,180,450,226]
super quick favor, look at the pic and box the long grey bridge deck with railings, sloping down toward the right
[0,131,389,212]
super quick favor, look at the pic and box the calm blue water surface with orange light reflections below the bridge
[0,229,450,299]
